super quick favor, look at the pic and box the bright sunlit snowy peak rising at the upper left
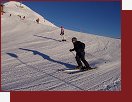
[4,1,56,27]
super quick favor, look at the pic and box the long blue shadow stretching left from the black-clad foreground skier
[19,48,76,69]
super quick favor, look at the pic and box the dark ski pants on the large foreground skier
[75,52,89,68]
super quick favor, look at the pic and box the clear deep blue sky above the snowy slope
[23,1,121,38]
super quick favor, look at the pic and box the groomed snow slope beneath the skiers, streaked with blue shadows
[1,1,121,91]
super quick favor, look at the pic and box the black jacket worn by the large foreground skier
[72,41,85,53]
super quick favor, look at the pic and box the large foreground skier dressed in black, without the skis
[69,37,91,70]
